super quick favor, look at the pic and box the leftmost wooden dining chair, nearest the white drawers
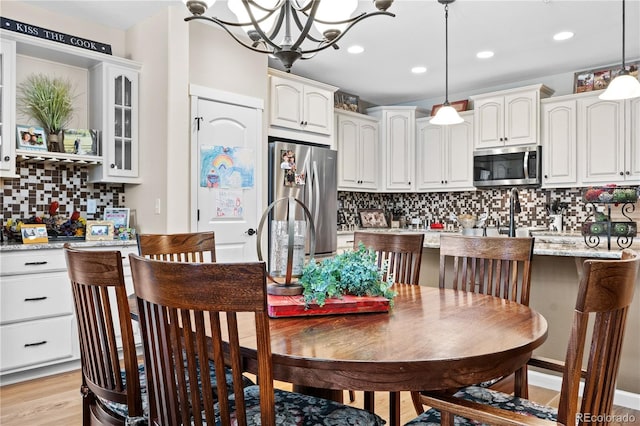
[64,243,146,426]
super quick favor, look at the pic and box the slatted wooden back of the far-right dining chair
[558,250,640,424]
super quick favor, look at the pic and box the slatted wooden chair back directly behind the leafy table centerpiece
[353,231,424,284]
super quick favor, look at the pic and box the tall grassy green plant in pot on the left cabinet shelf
[19,74,74,152]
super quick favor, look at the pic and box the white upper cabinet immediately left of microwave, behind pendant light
[416,112,475,192]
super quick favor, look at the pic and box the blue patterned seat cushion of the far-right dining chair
[405,386,558,426]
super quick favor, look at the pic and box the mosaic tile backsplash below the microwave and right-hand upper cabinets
[338,188,638,232]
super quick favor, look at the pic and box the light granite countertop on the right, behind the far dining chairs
[338,229,640,259]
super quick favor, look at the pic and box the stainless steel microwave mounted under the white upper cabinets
[473,145,542,187]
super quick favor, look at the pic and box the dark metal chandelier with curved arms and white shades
[183,0,395,72]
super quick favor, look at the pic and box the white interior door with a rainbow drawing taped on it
[192,98,262,262]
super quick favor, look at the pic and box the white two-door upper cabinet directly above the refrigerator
[269,69,337,145]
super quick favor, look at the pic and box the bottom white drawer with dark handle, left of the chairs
[0,315,78,371]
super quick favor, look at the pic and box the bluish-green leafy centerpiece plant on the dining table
[298,243,396,306]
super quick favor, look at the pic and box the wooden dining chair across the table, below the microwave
[411,234,534,414]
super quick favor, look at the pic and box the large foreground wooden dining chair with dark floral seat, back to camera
[129,254,384,426]
